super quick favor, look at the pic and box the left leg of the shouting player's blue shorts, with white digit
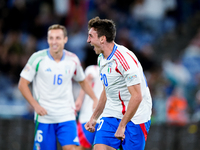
[94,117,121,149]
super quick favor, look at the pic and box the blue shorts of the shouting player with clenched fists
[94,117,151,150]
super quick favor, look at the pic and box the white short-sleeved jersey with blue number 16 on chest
[20,49,85,123]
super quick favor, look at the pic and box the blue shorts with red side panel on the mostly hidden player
[78,123,98,148]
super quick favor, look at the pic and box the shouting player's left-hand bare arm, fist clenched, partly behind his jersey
[85,88,107,132]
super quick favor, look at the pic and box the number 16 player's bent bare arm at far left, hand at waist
[18,77,47,116]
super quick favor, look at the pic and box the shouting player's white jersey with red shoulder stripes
[98,44,152,124]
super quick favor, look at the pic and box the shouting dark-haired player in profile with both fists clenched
[85,17,152,150]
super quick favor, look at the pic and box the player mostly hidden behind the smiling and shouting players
[75,65,103,150]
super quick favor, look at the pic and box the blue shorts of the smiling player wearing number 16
[33,120,79,150]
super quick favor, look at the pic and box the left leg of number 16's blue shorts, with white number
[33,123,57,150]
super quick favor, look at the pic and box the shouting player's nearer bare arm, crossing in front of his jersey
[115,84,142,140]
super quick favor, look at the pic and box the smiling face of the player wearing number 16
[47,29,67,53]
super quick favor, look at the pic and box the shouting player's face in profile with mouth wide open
[87,28,102,54]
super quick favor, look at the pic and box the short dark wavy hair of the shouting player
[88,17,116,43]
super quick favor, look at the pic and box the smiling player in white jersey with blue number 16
[18,24,98,150]
